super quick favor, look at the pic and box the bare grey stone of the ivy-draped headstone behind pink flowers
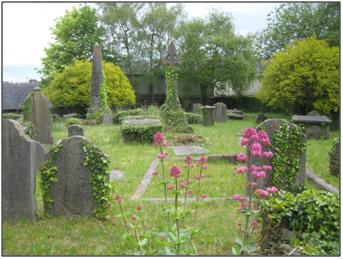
[247,119,306,193]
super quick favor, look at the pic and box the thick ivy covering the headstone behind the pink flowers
[270,121,306,192]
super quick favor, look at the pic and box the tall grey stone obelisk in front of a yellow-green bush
[90,44,103,111]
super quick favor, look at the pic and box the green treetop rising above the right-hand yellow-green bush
[255,2,340,60]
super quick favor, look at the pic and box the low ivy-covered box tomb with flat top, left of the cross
[121,122,162,144]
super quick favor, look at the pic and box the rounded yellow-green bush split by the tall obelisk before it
[44,60,136,107]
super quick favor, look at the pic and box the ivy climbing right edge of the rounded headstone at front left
[83,142,111,219]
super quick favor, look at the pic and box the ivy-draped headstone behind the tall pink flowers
[247,119,306,193]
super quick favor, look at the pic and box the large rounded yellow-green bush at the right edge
[257,38,339,114]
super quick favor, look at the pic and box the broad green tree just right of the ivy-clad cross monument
[179,11,256,103]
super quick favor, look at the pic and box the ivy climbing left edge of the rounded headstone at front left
[39,144,62,212]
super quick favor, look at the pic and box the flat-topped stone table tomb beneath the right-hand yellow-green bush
[292,115,331,139]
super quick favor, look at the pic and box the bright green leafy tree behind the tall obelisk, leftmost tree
[40,6,104,86]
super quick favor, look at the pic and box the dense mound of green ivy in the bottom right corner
[259,189,340,255]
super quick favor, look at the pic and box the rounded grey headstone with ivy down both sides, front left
[40,136,110,217]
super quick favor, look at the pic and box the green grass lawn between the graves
[2,113,338,255]
